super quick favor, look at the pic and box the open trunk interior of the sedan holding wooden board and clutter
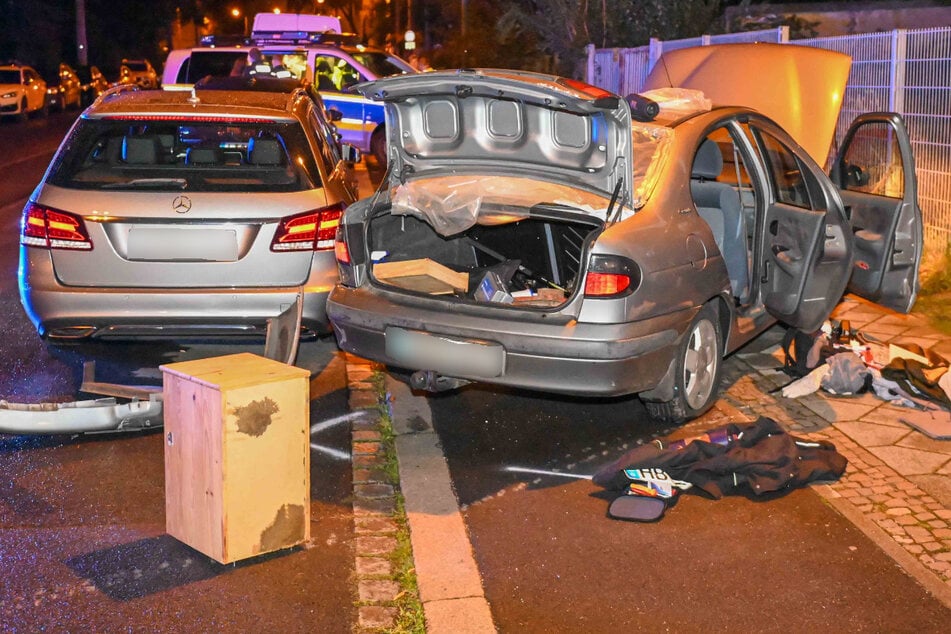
[367,206,604,311]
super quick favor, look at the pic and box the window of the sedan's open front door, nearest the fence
[839,121,905,198]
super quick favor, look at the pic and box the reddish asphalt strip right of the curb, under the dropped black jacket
[429,368,951,633]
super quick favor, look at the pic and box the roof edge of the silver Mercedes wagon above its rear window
[85,90,296,119]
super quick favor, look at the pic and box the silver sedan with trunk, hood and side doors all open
[328,46,922,422]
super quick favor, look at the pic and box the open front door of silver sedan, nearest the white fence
[831,112,924,313]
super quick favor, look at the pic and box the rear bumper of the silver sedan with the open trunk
[327,286,694,396]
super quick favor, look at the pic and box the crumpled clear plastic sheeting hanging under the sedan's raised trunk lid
[391,174,620,236]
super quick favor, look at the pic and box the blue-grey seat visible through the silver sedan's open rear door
[690,139,749,303]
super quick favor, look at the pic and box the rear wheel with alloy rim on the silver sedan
[644,304,723,424]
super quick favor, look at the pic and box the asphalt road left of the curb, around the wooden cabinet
[0,107,354,633]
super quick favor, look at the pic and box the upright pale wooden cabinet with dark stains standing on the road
[161,353,310,563]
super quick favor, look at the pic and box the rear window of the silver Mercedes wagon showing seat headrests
[49,119,320,192]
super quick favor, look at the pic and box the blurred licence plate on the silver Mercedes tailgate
[128,227,238,262]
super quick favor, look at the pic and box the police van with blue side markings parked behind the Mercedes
[162,13,416,165]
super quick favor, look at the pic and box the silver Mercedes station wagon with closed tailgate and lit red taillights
[19,86,356,341]
